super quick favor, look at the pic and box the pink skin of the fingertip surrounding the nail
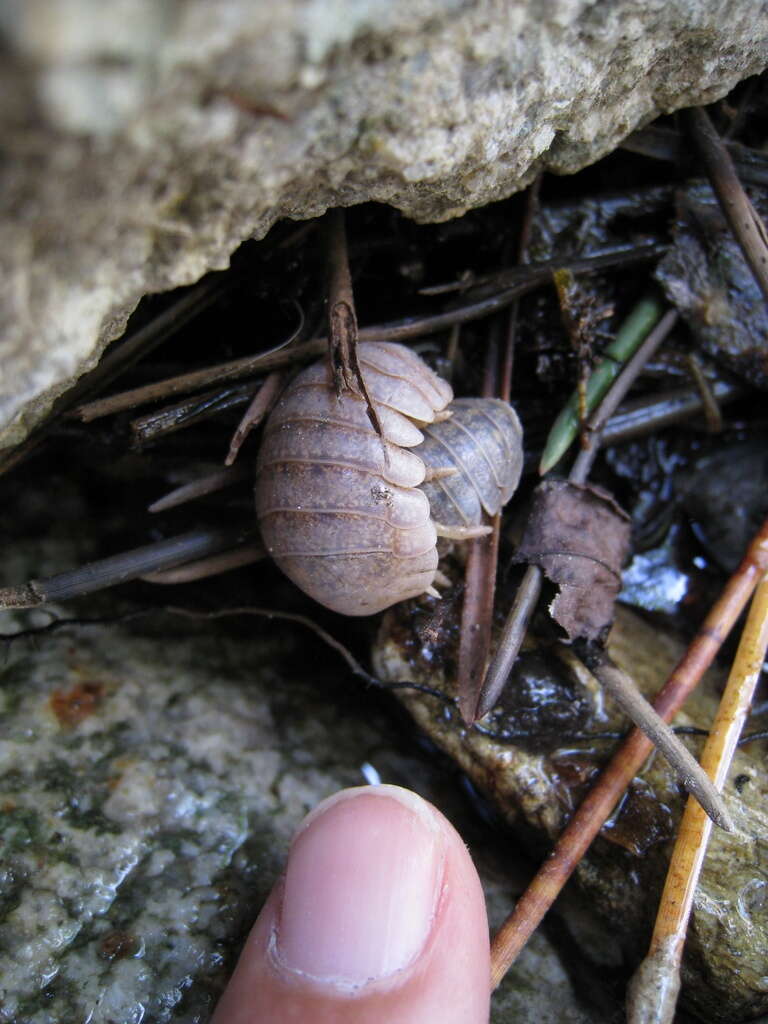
[212,786,490,1024]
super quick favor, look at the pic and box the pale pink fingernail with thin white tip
[276,786,444,989]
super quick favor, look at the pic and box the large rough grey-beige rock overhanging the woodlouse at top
[0,0,768,445]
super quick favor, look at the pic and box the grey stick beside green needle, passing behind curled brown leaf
[475,310,677,719]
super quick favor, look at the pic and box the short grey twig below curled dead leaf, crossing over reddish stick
[568,652,733,831]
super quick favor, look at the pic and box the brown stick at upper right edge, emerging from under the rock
[683,108,768,307]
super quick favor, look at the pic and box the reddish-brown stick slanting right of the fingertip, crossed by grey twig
[490,519,768,987]
